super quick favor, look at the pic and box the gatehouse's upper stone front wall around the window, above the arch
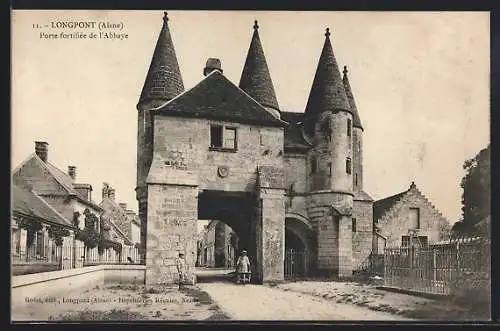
[154,116,283,192]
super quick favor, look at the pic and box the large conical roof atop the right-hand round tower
[305,28,351,116]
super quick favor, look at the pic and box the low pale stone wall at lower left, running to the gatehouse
[11,265,146,307]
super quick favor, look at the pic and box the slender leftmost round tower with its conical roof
[136,13,184,262]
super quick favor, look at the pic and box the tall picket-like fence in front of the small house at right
[384,240,490,294]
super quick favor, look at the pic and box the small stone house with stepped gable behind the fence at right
[372,182,450,254]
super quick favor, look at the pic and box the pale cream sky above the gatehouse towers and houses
[11,11,490,233]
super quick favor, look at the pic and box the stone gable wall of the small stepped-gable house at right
[377,188,450,247]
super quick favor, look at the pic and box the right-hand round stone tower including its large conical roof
[304,29,353,277]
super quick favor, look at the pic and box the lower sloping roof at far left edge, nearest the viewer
[12,184,73,228]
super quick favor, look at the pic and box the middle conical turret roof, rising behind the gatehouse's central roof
[239,21,279,111]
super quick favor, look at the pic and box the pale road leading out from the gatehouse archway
[198,269,408,321]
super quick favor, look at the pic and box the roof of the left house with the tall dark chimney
[13,153,101,210]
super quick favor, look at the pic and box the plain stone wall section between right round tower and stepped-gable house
[351,200,373,270]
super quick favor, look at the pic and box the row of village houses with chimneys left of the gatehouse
[11,141,140,275]
